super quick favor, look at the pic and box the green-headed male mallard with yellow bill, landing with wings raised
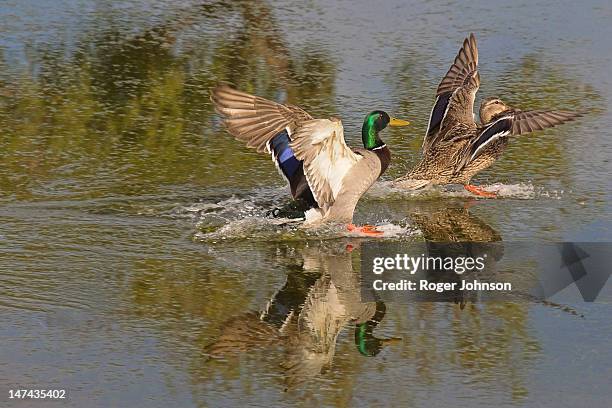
[211,85,408,234]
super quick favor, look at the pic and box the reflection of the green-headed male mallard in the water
[205,239,400,388]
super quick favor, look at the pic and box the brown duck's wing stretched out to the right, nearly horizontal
[460,110,582,168]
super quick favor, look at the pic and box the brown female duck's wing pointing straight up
[423,34,480,152]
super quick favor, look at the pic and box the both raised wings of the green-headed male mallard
[211,85,361,208]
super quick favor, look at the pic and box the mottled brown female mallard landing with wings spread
[394,34,580,197]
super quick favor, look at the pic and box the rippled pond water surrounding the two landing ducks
[0,0,612,407]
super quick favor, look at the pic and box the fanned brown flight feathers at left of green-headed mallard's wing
[211,85,312,153]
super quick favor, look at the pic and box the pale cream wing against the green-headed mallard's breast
[291,119,362,208]
